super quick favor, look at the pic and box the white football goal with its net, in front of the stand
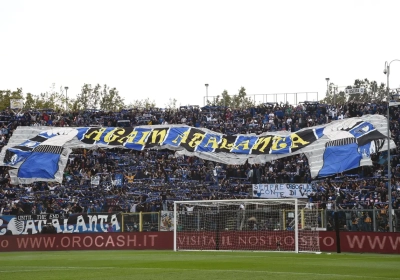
[174,199,320,252]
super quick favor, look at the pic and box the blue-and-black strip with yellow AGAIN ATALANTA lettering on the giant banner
[77,126,322,155]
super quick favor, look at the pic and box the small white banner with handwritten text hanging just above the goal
[253,184,313,198]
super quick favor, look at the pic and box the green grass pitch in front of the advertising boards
[0,251,400,280]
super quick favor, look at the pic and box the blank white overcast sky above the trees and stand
[0,0,400,107]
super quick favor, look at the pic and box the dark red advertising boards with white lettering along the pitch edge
[0,232,400,254]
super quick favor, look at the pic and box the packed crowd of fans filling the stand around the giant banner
[0,102,400,231]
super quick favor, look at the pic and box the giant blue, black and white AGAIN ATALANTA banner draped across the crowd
[0,115,395,184]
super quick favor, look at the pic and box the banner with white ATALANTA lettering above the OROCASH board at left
[0,213,121,235]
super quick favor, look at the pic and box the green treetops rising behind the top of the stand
[0,79,387,111]
